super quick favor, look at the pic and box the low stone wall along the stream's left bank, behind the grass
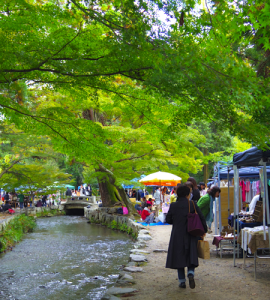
[0,205,64,232]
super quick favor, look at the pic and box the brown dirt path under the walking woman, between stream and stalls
[126,225,270,300]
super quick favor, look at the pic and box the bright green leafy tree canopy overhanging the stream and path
[0,0,269,209]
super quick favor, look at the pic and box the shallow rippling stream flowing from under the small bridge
[0,216,132,300]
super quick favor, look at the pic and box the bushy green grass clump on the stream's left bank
[0,214,36,252]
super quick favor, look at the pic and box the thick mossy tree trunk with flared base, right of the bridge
[97,164,138,215]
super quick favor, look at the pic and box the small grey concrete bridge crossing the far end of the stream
[62,196,98,216]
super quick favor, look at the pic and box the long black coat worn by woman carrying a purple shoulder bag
[166,197,207,269]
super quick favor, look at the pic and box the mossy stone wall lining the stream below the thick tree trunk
[84,207,145,239]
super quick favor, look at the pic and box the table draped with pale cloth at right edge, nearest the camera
[237,226,270,280]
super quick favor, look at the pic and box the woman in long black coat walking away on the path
[166,185,207,289]
